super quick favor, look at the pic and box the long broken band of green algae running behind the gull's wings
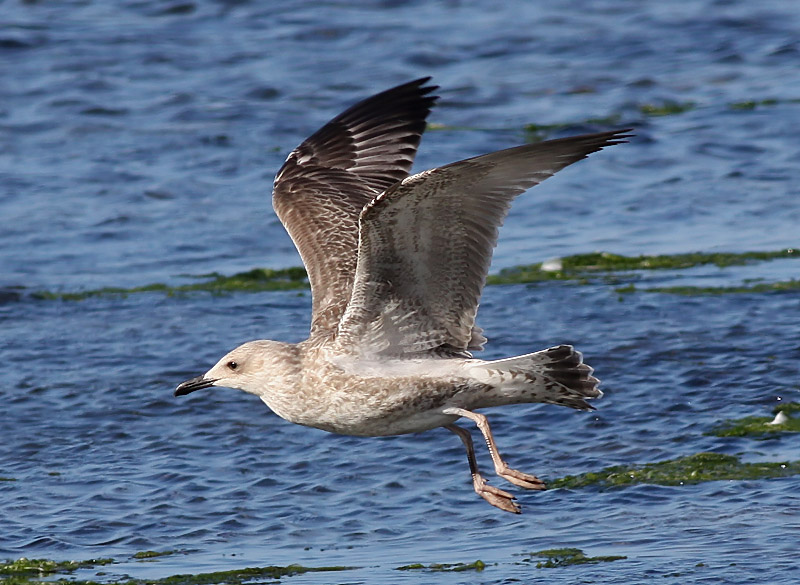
[32,248,800,301]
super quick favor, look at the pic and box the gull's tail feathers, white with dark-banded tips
[476,345,603,410]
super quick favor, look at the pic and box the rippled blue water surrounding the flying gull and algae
[0,0,800,583]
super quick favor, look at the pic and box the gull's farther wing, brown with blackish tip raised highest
[272,77,436,336]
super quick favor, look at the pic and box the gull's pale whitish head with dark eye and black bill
[175,340,295,396]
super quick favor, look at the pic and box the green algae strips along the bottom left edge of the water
[0,551,357,585]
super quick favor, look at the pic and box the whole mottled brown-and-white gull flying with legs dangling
[175,78,628,513]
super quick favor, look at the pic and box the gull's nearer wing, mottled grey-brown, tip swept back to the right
[337,130,627,354]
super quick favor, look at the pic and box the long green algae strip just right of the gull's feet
[549,453,800,488]
